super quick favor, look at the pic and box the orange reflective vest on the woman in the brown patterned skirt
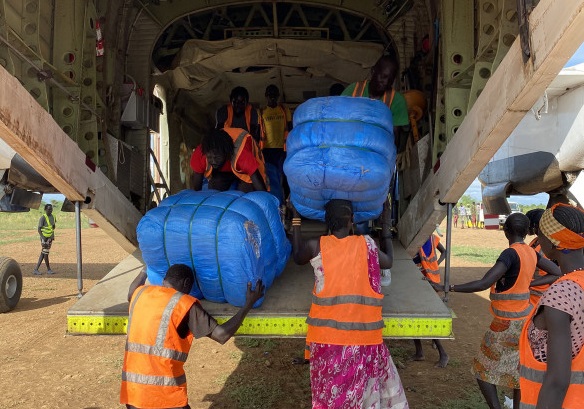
[490,243,537,320]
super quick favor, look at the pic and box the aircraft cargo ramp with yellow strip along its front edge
[67,237,452,339]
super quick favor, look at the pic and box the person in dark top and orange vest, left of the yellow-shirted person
[215,87,260,144]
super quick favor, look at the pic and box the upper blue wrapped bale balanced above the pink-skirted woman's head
[284,97,396,222]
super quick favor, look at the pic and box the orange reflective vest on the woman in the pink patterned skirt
[306,235,384,345]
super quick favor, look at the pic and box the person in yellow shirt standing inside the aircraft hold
[260,84,292,206]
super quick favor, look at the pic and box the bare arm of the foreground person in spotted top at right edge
[536,306,572,409]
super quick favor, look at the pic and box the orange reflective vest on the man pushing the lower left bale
[120,285,197,409]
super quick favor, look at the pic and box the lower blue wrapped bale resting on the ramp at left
[137,190,291,307]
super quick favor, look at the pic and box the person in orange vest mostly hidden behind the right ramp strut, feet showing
[412,234,449,368]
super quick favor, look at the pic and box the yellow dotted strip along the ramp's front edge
[67,315,452,339]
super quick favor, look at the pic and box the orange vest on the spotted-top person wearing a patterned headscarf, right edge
[519,270,584,409]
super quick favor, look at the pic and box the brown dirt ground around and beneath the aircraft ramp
[0,228,507,409]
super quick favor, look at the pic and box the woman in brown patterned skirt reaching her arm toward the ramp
[430,213,560,409]
